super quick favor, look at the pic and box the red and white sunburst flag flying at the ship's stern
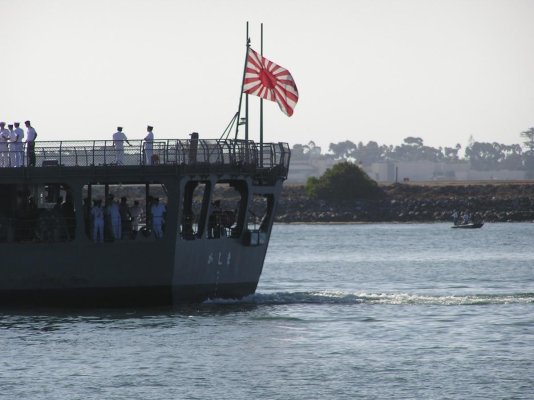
[243,48,299,117]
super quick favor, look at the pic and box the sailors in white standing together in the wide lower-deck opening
[90,194,167,243]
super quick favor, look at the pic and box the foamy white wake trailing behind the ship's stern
[207,291,534,306]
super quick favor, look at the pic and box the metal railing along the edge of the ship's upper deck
[0,139,290,174]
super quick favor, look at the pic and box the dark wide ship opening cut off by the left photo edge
[0,183,76,243]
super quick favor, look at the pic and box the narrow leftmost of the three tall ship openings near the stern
[180,181,210,240]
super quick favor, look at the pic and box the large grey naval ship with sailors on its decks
[0,136,290,307]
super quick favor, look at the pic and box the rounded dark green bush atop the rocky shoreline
[306,162,383,202]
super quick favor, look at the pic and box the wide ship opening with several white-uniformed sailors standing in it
[83,183,168,242]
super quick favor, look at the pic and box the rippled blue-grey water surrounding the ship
[0,223,534,400]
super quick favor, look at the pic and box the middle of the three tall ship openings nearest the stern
[208,181,246,239]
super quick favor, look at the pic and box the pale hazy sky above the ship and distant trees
[0,0,534,150]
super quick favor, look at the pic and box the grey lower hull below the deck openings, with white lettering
[0,222,267,307]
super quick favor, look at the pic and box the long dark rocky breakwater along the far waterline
[275,183,534,223]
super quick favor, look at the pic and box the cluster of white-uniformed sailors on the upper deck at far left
[0,121,37,168]
